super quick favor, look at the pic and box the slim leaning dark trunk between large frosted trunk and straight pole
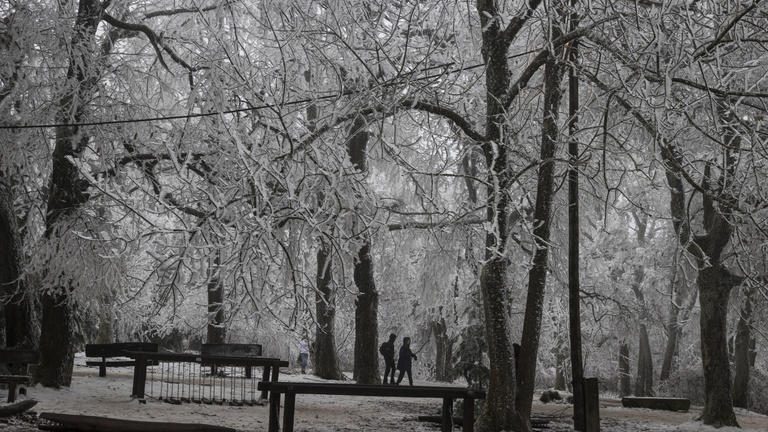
[516,49,573,421]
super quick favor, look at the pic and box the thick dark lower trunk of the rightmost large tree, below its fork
[697,266,738,427]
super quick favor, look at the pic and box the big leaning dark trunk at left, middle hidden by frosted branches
[36,0,102,387]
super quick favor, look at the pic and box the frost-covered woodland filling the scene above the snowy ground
[0,0,768,430]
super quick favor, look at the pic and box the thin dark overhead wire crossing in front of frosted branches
[0,50,539,130]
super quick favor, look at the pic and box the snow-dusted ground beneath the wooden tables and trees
[0,356,768,432]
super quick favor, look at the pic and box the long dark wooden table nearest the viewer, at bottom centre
[259,381,485,432]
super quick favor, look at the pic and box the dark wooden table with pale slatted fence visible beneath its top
[128,351,288,399]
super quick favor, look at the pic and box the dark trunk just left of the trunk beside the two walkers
[314,239,344,380]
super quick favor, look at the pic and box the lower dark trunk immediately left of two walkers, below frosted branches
[354,241,381,384]
